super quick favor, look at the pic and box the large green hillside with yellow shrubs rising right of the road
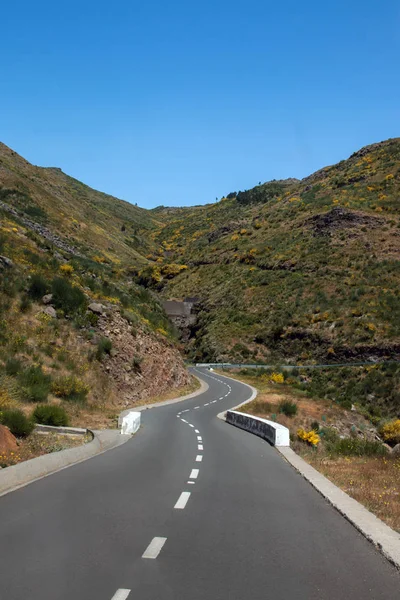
[148,139,400,363]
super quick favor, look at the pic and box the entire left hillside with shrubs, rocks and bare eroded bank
[0,145,191,426]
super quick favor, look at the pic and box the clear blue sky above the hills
[0,0,400,208]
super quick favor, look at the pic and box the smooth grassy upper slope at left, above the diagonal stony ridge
[0,143,156,265]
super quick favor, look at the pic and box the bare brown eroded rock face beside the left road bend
[97,312,190,406]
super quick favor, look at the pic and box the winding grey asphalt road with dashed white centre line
[0,371,400,600]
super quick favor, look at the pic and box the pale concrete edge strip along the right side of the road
[208,373,400,570]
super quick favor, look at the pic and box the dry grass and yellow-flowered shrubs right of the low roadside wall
[221,367,400,531]
